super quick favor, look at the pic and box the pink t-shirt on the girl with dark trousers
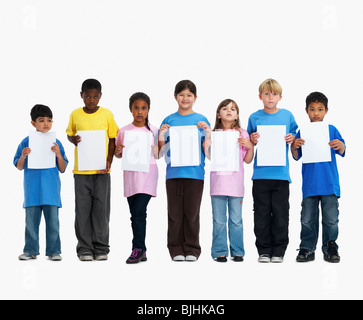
[116,123,159,197]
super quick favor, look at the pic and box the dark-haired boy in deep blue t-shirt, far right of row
[291,92,345,263]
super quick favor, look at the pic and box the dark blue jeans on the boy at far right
[300,195,339,252]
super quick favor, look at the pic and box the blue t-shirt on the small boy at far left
[13,137,68,208]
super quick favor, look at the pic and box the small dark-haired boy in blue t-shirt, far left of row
[13,104,68,261]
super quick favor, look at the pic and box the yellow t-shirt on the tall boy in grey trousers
[66,107,118,174]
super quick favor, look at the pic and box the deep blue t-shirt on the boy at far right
[296,125,345,199]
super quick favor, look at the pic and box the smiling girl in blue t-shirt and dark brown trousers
[158,80,209,261]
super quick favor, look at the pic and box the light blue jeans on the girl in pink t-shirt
[211,196,245,259]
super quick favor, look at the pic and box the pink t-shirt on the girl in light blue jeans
[210,129,250,197]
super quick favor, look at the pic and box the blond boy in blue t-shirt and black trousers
[247,79,297,262]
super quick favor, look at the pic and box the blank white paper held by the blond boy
[257,125,286,166]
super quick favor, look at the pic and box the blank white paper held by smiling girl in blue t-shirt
[169,126,200,167]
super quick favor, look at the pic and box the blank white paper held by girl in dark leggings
[122,130,153,172]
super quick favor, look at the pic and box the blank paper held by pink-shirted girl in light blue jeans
[210,130,239,171]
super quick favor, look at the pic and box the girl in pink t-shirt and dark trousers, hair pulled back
[115,92,158,263]
